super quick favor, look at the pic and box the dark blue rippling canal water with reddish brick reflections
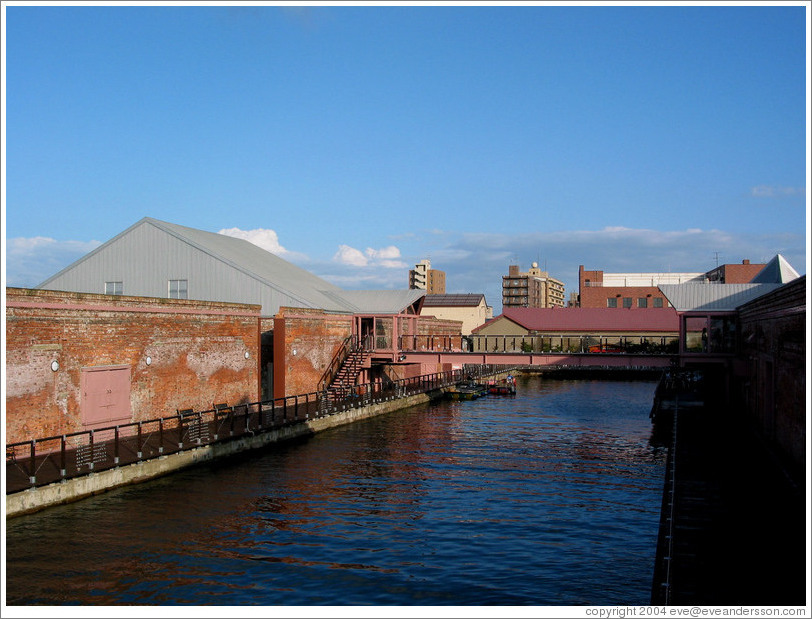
[6,376,665,606]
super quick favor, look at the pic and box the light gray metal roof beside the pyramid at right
[659,283,783,312]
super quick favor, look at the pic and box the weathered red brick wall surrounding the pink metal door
[5,288,260,443]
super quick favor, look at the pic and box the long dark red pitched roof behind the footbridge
[474,307,679,333]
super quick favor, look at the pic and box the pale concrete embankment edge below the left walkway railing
[6,389,444,518]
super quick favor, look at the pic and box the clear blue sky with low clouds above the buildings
[3,3,809,312]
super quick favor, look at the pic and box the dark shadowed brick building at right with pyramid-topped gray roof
[663,268,808,480]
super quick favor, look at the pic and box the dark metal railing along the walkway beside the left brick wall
[6,366,506,494]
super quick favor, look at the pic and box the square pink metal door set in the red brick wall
[82,366,132,429]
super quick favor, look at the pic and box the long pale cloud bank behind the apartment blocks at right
[417,226,807,311]
